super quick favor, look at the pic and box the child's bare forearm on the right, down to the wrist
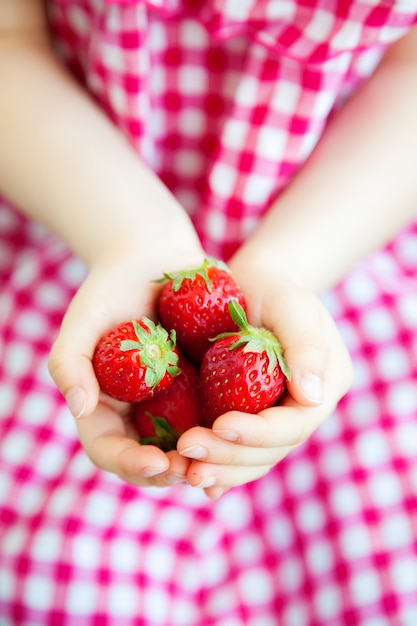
[232,27,417,292]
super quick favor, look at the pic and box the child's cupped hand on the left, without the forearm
[49,245,203,486]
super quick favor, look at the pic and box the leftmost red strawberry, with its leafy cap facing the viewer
[93,317,179,402]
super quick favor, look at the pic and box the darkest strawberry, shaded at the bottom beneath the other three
[133,355,201,452]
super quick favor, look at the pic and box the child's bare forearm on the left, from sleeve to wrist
[0,0,202,265]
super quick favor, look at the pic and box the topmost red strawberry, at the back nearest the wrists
[158,259,245,363]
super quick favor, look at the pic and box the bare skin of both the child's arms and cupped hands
[0,0,417,498]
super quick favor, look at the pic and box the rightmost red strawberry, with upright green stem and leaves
[200,302,290,427]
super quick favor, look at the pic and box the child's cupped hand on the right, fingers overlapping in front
[178,261,352,497]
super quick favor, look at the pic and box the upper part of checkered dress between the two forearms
[48,0,417,258]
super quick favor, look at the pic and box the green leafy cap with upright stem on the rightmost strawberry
[211,300,291,380]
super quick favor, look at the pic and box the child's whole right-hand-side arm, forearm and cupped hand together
[178,28,417,497]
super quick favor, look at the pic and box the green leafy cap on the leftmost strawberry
[120,317,180,388]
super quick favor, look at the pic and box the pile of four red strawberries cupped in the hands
[93,259,290,451]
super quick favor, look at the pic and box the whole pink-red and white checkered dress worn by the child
[0,0,417,626]
